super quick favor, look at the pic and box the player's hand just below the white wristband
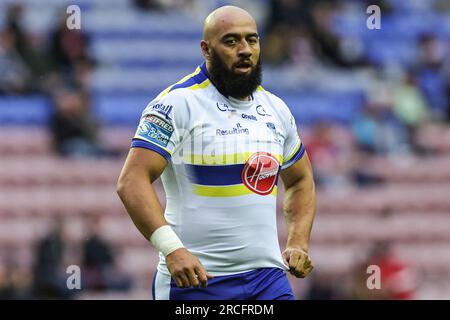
[166,248,213,288]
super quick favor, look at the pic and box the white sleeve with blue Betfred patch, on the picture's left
[131,93,186,161]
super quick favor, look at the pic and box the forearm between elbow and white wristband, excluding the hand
[117,175,167,240]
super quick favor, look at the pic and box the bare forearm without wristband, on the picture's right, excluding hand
[284,176,316,251]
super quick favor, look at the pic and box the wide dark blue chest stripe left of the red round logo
[186,164,245,186]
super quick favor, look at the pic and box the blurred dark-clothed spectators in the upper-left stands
[0,3,118,157]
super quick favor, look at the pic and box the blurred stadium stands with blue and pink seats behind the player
[0,0,450,299]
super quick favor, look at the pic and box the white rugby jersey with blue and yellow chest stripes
[132,63,305,275]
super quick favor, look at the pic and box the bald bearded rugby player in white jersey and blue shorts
[117,6,315,300]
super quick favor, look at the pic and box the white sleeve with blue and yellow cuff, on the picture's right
[281,106,305,169]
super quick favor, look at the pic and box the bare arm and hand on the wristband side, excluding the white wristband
[117,148,212,288]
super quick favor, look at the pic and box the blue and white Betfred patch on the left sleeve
[137,115,173,147]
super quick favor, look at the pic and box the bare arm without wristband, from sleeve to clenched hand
[281,153,316,278]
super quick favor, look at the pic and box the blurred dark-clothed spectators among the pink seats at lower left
[0,213,133,300]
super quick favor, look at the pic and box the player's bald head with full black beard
[200,6,261,98]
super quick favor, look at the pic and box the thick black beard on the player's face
[209,50,262,98]
